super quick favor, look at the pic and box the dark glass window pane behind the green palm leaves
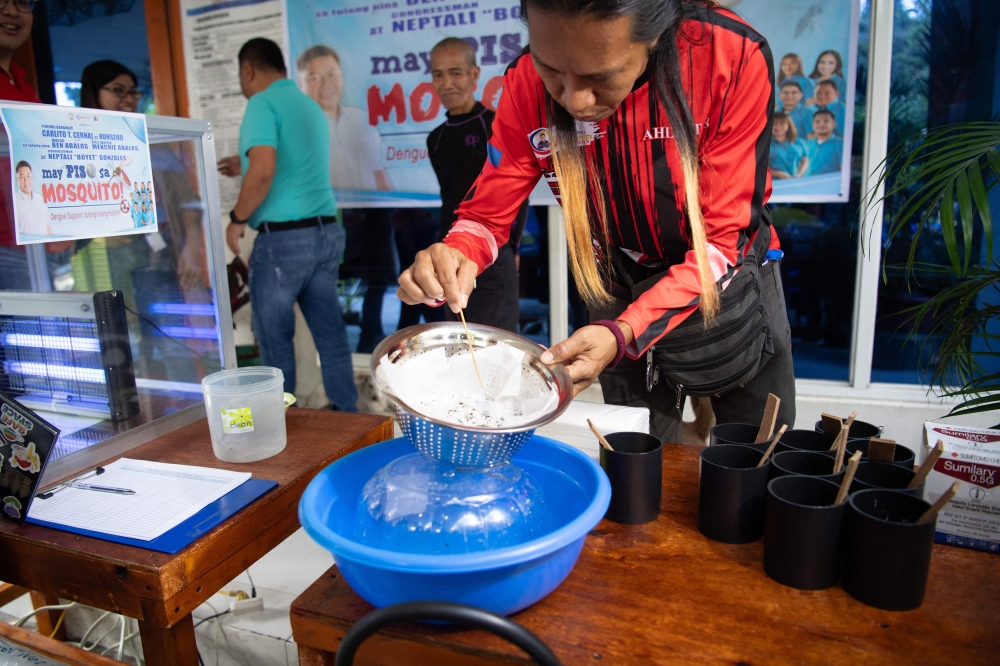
[872,0,1000,384]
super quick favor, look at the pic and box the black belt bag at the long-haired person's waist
[608,220,774,409]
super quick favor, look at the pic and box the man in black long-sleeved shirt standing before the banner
[427,37,528,333]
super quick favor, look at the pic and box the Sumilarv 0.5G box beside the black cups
[924,421,1000,553]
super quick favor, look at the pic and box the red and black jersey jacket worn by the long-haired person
[444,10,778,358]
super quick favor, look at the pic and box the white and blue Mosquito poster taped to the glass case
[0,104,157,245]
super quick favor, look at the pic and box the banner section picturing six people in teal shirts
[722,0,861,203]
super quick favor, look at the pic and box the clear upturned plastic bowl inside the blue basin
[356,453,546,555]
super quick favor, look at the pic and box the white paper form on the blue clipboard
[28,458,251,541]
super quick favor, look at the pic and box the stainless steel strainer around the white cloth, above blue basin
[371,322,573,467]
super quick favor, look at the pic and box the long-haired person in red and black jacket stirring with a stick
[398,0,795,442]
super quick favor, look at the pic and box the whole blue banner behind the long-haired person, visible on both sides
[285,0,859,207]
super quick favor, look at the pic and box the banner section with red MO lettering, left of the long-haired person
[286,0,555,207]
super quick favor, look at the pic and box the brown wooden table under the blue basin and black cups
[291,444,1000,666]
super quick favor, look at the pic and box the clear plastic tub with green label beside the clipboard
[201,367,285,463]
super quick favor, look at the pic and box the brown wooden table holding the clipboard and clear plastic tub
[0,409,393,666]
